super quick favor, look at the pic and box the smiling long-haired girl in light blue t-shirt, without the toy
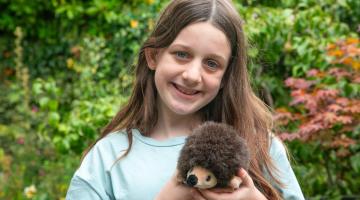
[67,0,303,200]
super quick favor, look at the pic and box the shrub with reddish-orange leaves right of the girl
[275,38,360,157]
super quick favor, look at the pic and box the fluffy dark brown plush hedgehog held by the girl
[177,122,249,189]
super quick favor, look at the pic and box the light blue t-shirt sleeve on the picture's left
[66,131,128,199]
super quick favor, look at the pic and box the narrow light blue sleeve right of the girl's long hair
[270,138,305,200]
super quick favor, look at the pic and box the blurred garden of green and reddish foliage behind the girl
[0,0,360,200]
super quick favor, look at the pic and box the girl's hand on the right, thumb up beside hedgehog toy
[199,169,266,200]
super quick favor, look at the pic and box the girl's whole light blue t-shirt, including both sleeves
[66,129,304,200]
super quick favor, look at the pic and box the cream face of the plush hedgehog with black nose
[185,167,217,189]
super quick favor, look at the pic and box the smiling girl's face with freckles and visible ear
[147,22,231,115]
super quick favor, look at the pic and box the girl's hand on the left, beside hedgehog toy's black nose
[155,173,207,200]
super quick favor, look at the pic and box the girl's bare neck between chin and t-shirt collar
[150,104,201,140]
